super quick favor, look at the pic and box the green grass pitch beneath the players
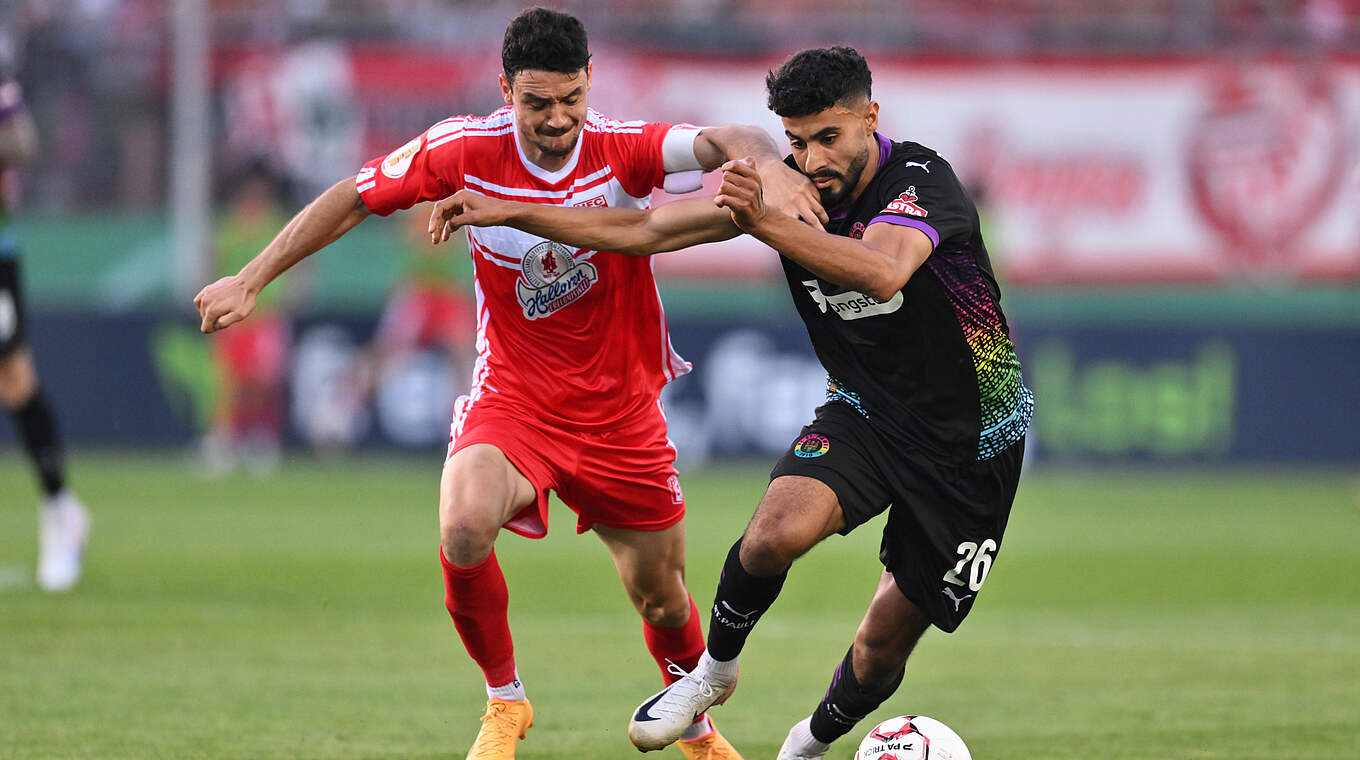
[0,449,1360,760]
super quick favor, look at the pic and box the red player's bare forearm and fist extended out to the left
[193,177,370,333]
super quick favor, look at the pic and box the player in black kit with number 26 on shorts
[430,48,1034,760]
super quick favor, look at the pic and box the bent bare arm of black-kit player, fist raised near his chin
[714,160,933,300]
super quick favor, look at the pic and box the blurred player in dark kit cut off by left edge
[0,71,90,591]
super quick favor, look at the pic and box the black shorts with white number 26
[770,401,1024,632]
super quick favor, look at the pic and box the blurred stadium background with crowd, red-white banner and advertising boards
[0,0,1360,470]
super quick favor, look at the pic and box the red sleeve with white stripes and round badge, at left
[355,118,465,216]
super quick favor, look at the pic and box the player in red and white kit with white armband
[194,8,826,760]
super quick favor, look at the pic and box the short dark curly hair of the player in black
[766,48,873,117]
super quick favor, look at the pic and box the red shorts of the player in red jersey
[449,394,684,538]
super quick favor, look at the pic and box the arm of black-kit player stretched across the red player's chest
[430,190,741,256]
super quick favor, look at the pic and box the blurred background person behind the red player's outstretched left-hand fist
[199,160,295,476]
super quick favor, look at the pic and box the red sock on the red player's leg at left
[439,547,514,687]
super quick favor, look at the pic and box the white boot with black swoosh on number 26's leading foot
[628,653,737,752]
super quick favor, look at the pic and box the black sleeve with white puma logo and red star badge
[869,154,976,247]
